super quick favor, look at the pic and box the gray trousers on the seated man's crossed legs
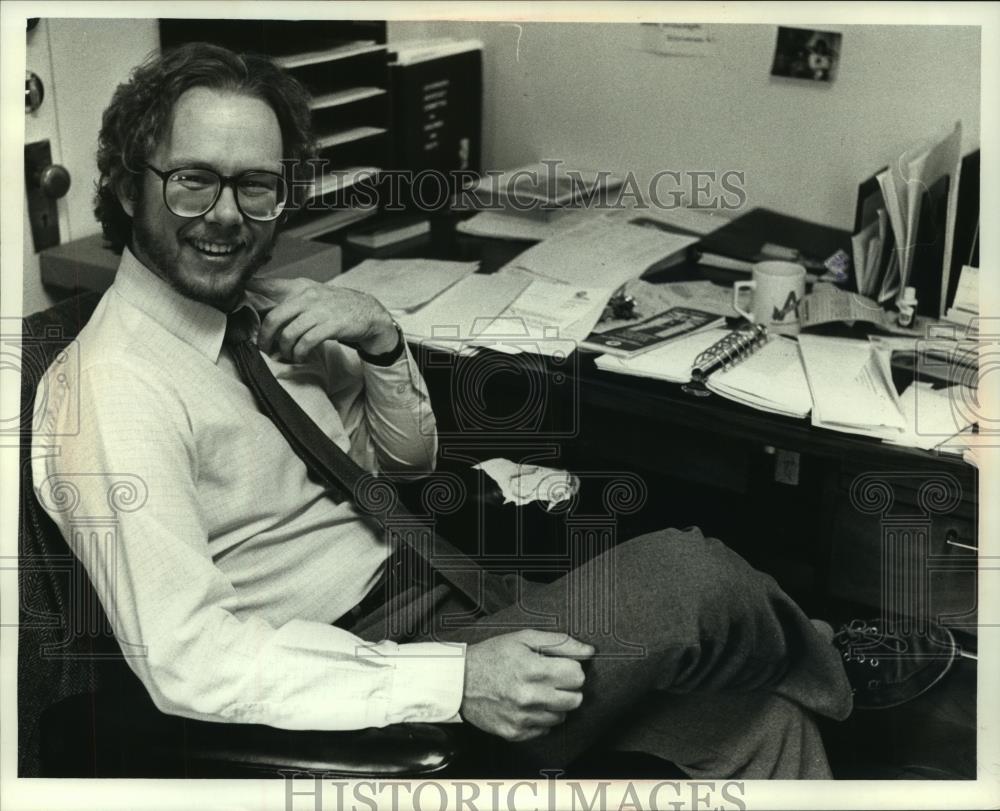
[351,528,851,779]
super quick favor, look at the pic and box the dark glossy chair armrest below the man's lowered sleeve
[41,691,462,779]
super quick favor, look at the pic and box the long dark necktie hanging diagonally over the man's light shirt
[226,307,509,611]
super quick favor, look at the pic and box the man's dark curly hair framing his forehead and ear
[94,42,314,252]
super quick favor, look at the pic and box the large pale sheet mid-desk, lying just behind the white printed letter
[511,220,697,290]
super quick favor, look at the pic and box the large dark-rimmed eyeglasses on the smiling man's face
[144,163,288,222]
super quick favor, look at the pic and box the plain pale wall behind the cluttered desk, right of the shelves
[389,22,980,228]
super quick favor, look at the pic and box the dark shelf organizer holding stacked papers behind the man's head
[160,19,392,241]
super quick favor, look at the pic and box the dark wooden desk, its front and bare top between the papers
[344,217,978,650]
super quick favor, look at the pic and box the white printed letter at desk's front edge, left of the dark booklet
[474,274,608,355]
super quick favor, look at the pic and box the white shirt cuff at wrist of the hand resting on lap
[372,642,466,724]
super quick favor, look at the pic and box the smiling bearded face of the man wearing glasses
[126,87,286,312]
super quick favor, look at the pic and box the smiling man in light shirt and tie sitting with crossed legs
[33,44,851,778]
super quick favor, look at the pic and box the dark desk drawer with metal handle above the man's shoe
[829,474,978,637]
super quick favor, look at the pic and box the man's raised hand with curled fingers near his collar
[247,277,399,363]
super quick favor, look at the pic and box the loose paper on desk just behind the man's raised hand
[329,259,479,312]
